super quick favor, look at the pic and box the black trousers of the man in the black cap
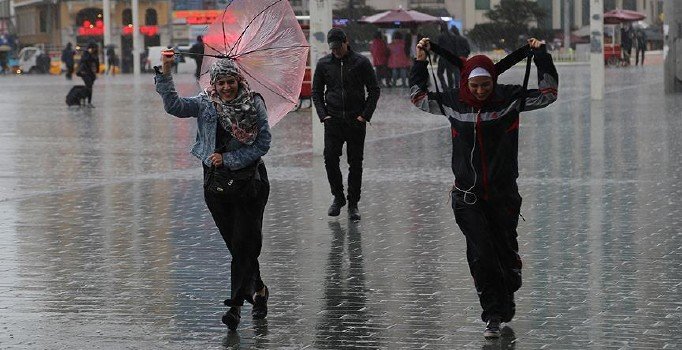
[324,117,367,206]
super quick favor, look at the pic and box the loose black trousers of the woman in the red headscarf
[452,191,522,322]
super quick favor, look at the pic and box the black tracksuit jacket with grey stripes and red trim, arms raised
[410,51,559,199]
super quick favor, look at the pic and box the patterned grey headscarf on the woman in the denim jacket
[206,58,258,145]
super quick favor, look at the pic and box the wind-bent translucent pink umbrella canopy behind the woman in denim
[199,0,310,126]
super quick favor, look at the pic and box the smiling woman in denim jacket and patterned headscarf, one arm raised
[155,49,271,330]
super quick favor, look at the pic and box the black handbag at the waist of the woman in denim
[204,159,262,199]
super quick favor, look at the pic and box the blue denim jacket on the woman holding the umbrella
[154,74,272,170]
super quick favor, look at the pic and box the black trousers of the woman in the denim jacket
[204,163,270,306]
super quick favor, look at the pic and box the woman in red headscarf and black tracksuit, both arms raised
[410,39,559,337]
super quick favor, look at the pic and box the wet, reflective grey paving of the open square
[0,65,682,350]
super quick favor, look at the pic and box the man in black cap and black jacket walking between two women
[313,28,379,221]
